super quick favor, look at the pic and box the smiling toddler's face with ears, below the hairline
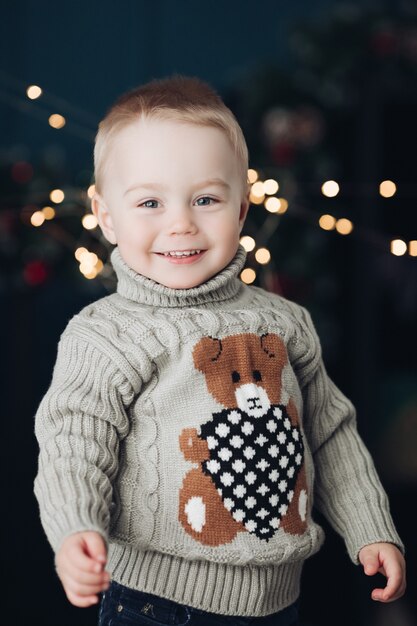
[92,119,249,289]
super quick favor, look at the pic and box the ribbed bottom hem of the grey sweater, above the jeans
[108,544,303,617]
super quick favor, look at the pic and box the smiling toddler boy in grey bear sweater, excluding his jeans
[35,76,405,624]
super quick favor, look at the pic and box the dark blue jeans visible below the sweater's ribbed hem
[99,581,298,626]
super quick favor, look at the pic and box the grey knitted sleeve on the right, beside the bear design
[296,309,404,563]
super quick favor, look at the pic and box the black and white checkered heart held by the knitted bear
[201,405,304,539]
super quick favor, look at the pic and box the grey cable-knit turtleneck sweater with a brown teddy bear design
[35,247,402,616]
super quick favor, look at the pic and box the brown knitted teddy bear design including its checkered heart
[179,333,307,546]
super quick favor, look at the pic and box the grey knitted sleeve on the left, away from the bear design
[35,323,140,551]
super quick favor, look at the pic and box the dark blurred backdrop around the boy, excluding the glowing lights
[0,0,417,626]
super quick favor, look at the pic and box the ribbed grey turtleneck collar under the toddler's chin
[110,245,246,307]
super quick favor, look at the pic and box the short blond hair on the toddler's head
[94,74,248,194]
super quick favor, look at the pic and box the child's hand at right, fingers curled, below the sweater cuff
[359,543,406,602]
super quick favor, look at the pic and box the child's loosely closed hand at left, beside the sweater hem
[55,531,110,607]
